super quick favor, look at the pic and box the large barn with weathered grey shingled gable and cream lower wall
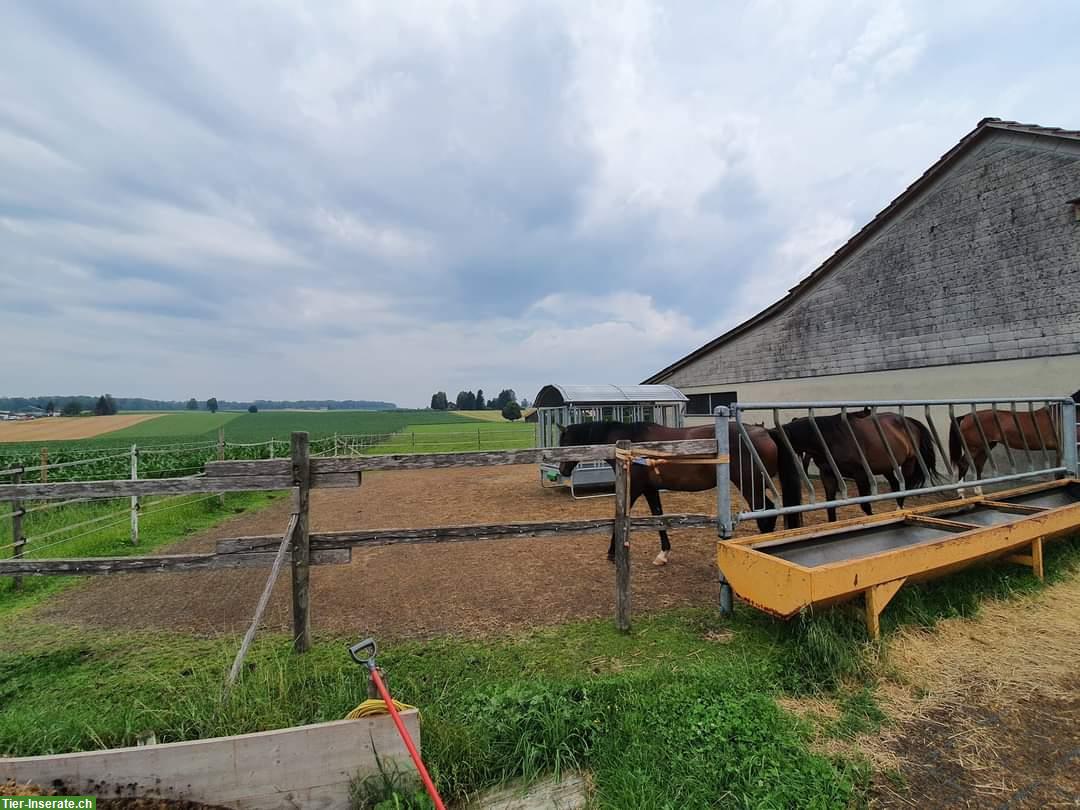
[645,119,1080,423]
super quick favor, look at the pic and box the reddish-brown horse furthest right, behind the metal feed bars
[948,391,1080,478]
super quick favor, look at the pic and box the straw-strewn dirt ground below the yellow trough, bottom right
[855,577,1080,810]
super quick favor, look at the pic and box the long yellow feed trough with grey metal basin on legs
[717,478,1080,637]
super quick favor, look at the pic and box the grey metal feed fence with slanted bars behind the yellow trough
[715,395,1080,537]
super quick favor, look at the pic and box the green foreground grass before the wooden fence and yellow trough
[0,540,1080,810]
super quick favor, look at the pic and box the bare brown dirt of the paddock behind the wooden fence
[42,465,920,638]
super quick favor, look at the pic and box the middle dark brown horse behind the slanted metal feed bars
[778,408,944,521]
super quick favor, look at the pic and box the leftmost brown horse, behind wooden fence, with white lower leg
[558,421,800,565]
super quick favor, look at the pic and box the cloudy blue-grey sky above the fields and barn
[0,0,1080,407]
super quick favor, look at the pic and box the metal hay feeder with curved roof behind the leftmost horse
[532,384,687,498]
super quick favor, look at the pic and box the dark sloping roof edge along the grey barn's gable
[645,118,1080,383]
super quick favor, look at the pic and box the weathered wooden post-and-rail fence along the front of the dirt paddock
[0,433,717,652]
